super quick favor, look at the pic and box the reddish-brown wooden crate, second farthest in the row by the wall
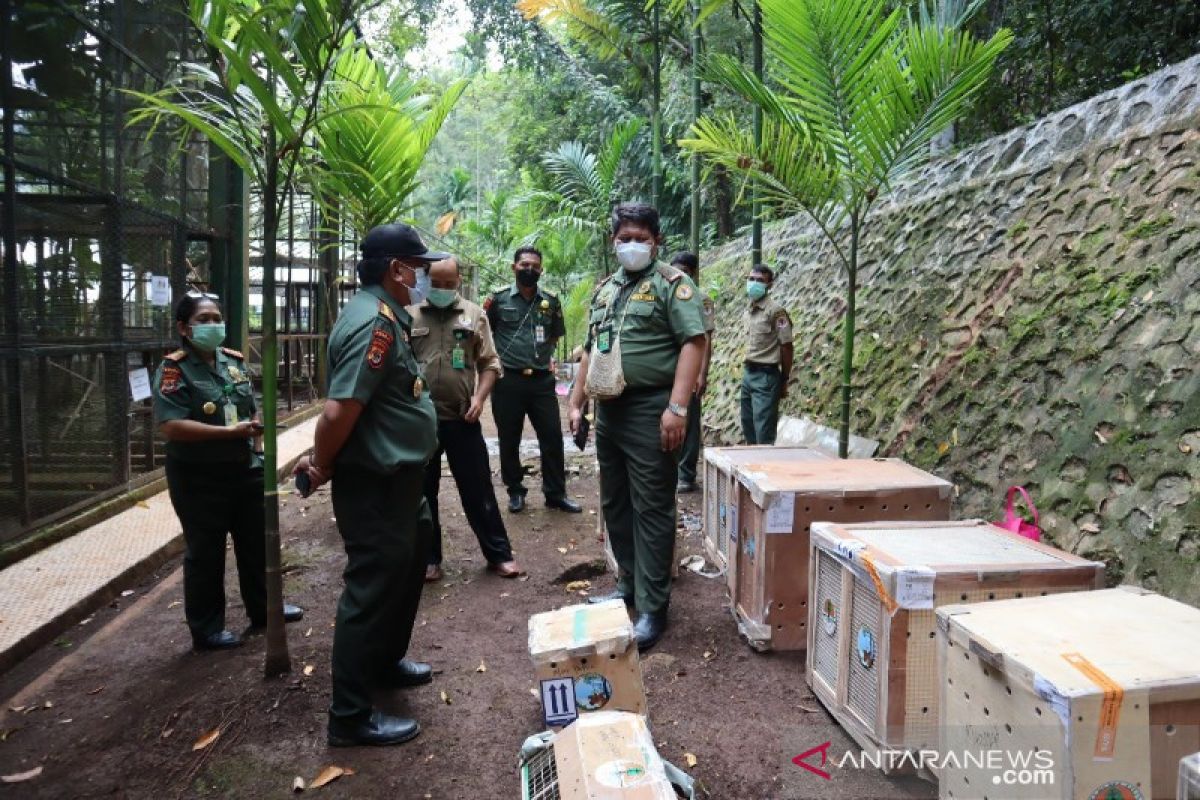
[732,458,952,650]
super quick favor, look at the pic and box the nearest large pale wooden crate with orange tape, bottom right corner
[937,587,1200,800]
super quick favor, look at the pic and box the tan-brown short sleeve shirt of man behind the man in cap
[408,292,500,420]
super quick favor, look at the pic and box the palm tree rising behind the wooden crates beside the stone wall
[679,0,1012,458]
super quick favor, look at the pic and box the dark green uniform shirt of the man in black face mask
[484,285,566,372]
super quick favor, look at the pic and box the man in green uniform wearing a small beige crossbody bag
[570,203,704,650]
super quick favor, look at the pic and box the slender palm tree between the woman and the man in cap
[128,0,365,676]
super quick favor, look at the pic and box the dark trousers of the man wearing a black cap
[329,467,433,721]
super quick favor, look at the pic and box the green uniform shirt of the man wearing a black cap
[329,285,437,474]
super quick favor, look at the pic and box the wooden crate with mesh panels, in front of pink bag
[805,519,1104,771]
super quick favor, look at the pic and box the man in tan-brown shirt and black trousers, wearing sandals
[408,258,523,581]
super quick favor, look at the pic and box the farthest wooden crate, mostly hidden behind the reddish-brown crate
[702,445,833,591]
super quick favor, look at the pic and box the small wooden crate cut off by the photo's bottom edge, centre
[521,711,678,800]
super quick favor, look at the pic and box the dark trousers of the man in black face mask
[492,372,566,500]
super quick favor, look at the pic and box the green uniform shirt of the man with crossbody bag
[584,263,706,389]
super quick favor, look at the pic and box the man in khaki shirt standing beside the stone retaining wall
[742,264,794,445]
